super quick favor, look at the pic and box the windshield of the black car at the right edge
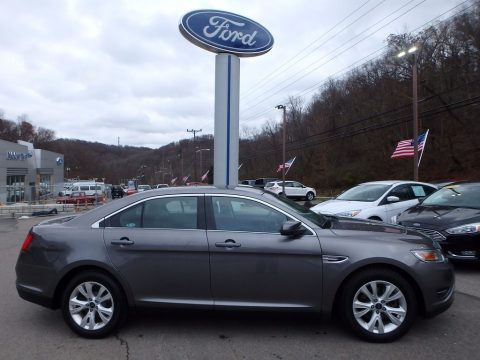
[422,183,480,209]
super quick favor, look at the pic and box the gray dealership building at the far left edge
[0,140,64,204]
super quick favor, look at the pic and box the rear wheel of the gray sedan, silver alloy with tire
[62,272,126,338]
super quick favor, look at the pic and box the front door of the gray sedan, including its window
[206,195,322,308]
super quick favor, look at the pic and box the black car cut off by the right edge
[396,182,480,260]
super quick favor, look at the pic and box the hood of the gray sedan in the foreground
[330,218,434,248]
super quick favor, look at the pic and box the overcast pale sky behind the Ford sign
[0,0,470,148]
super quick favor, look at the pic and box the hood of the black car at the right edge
[397,205,480,229]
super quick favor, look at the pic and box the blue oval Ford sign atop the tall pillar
[179,10,273,57]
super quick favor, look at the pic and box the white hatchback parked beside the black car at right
[310,181,437,223]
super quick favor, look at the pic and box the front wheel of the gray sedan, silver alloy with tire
[342,269,417,342]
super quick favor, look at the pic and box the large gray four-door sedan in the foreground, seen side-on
[16,187,454,341]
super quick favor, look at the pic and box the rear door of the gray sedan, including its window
[104,195,212,306]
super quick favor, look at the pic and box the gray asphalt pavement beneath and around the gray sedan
[0,218,480,360]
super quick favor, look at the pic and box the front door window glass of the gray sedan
[212,196,287,233]
